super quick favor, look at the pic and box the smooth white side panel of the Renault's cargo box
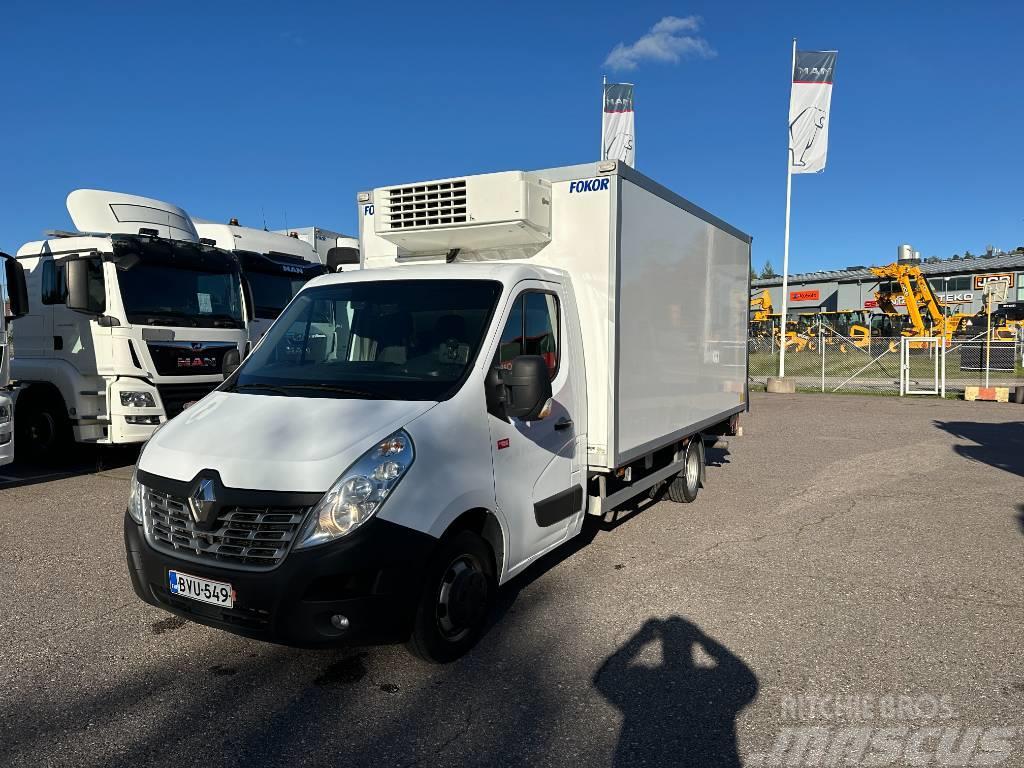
[614,179,750,465]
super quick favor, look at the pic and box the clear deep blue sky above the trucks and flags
[0,0,1024,272]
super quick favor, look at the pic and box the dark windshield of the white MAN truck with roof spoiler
[114,239,245,328]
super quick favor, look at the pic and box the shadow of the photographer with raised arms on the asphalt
[594,616,758,768]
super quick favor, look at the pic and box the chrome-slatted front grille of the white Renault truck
[146,488,306,569]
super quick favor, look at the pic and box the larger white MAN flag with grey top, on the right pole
[790,50,837,173]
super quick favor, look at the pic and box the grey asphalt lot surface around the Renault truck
[0,394,1024,768]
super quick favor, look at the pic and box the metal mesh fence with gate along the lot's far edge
[748,325,1024,395]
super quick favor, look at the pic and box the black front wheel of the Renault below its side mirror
[407,530,498,664]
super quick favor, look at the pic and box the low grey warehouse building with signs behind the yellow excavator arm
[751,248,1024,316]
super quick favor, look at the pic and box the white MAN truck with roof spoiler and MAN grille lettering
[11,189,246,459]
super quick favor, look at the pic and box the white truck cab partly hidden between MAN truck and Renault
[193,219,327,344]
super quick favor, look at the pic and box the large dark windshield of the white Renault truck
[227,280,502,400]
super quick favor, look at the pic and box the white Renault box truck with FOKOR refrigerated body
[125,162,751,662]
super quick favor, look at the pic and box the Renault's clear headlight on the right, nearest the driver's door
[297,429,415,548]
